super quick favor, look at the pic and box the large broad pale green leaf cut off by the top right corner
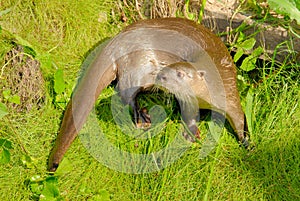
[268,0,300,24]
